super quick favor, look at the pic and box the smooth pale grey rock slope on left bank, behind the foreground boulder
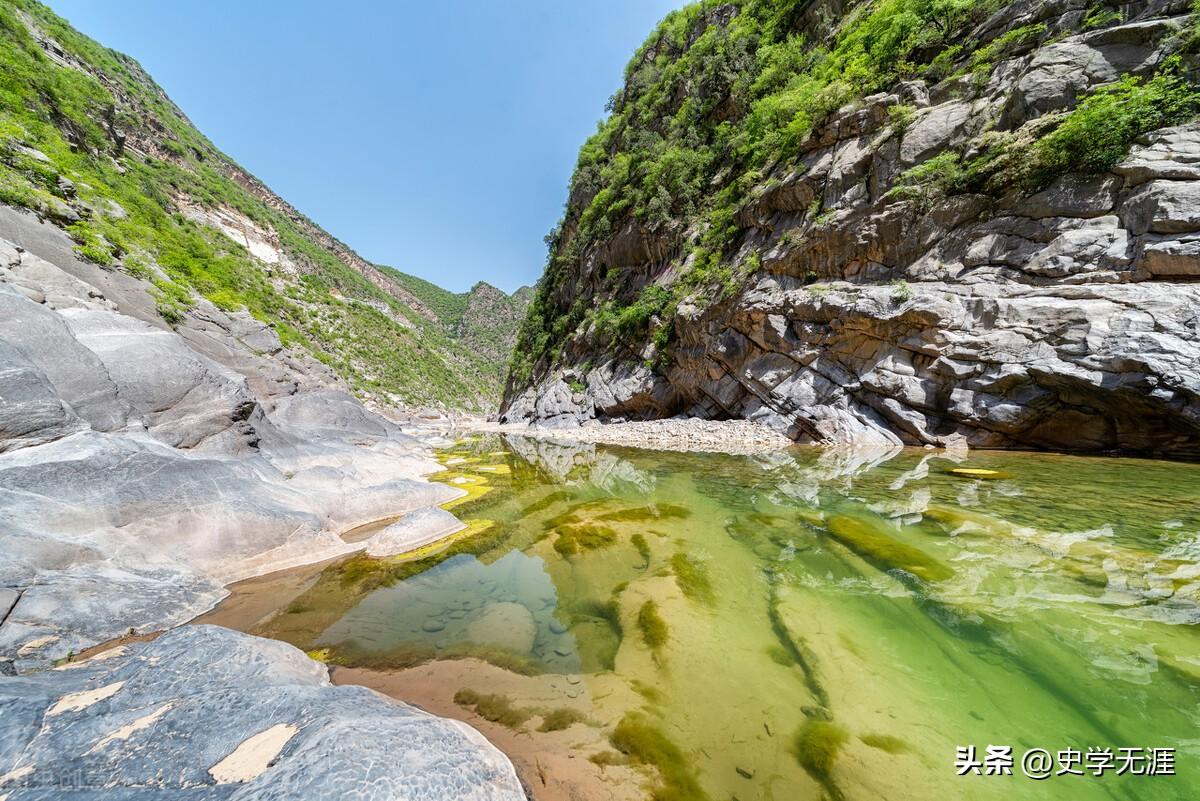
[0,209,462,668]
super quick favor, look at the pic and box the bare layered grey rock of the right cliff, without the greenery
[504,2,1200,456]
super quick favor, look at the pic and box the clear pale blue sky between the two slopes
[48,0,683,291]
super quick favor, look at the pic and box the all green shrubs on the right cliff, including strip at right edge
[509,0,1198,393]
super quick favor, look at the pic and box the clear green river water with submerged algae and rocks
[238,438,1200,801]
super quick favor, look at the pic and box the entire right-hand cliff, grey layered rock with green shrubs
[503,0,1200,454]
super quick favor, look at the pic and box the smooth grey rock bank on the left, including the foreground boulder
[0,206,524,801]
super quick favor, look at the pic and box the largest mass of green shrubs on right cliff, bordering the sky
[501,0,1000,386]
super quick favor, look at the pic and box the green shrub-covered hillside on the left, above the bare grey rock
[0,0,498,409]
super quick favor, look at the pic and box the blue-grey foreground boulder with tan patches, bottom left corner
[0,626,526,801]
